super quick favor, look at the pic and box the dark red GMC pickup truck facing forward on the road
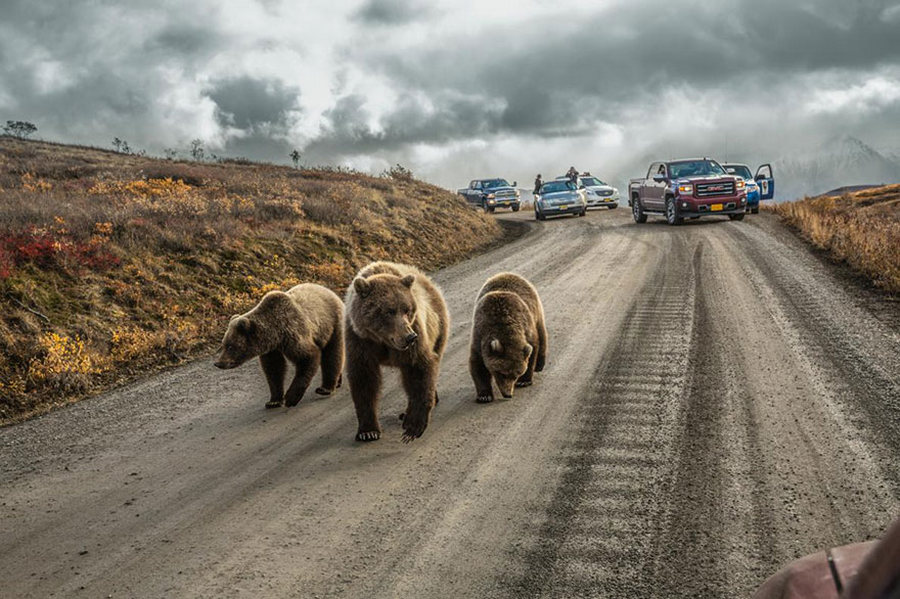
[628,158,747,225]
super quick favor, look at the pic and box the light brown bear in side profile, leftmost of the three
[215,283,344,408]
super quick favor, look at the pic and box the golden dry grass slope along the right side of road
[773,185,900,293]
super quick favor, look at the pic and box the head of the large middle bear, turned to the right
[351,274,419,351]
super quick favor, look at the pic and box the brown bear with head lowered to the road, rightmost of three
[469,273,547,403]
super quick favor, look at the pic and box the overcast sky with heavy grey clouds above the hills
[0,0,900,187]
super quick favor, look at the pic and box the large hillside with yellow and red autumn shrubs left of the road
[0,137,500,422]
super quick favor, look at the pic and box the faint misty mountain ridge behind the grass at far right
[774,135,900,201]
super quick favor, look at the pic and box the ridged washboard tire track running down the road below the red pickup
[509,237,702,597]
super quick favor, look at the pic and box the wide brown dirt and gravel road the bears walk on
[0,209,900,598]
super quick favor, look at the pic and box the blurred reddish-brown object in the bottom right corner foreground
[753,519,900,599]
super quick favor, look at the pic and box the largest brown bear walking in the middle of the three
[344,262,450,443]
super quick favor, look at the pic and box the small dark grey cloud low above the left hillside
[205,76,300,132]
